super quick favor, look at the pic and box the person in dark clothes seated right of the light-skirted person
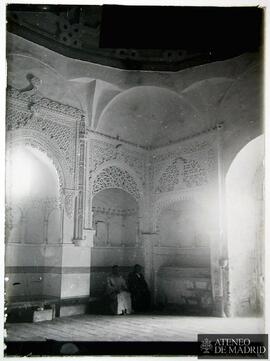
[128,264,151,312]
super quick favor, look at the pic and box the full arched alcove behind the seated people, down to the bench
[90,188,143,297]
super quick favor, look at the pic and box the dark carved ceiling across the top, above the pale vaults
[7,4,263,71]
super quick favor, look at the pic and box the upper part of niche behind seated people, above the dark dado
[92,188,139,246]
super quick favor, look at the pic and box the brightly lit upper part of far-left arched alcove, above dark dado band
[6,144,61,244]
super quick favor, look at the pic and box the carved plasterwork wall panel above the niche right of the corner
[150,130,218,228]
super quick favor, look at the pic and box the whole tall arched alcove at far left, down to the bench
[5,144,61,304]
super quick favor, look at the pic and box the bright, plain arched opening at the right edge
[226,136,264,316]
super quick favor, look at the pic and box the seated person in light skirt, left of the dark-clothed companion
[106,265,132,315]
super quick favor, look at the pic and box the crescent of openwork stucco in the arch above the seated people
[92,166,141,200]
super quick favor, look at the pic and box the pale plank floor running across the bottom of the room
[5,315,264,341]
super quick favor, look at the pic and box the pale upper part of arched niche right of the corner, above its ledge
[157,200,209,248]
